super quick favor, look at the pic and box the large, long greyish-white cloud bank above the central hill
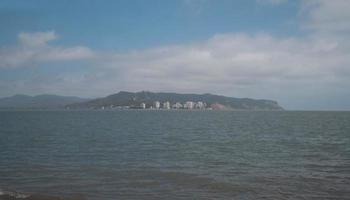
[91,34,350,93]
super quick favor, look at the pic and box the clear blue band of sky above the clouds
[0,0,299,50]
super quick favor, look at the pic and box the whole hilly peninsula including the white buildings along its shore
[66,91,283,110]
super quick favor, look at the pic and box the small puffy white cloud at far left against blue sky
[0,31,94,68]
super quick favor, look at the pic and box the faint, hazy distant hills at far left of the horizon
[0,94,89,109]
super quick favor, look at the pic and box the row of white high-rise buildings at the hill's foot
[140,101,207,110]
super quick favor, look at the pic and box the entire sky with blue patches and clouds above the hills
[0,0,350,110]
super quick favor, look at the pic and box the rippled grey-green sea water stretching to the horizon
[0,111,350,200]
